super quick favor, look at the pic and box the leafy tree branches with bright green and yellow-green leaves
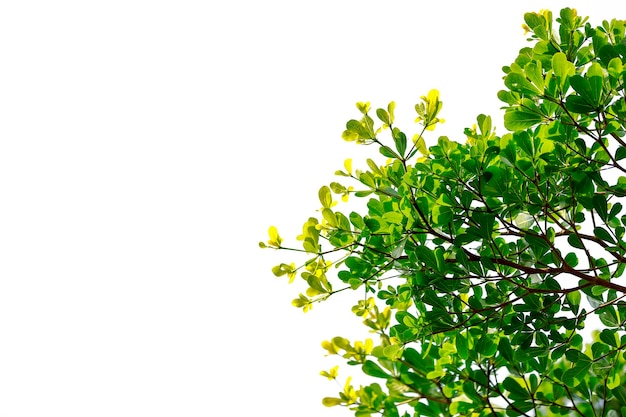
[261,8,626,417]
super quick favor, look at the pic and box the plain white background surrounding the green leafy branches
[0,0,626,417]
